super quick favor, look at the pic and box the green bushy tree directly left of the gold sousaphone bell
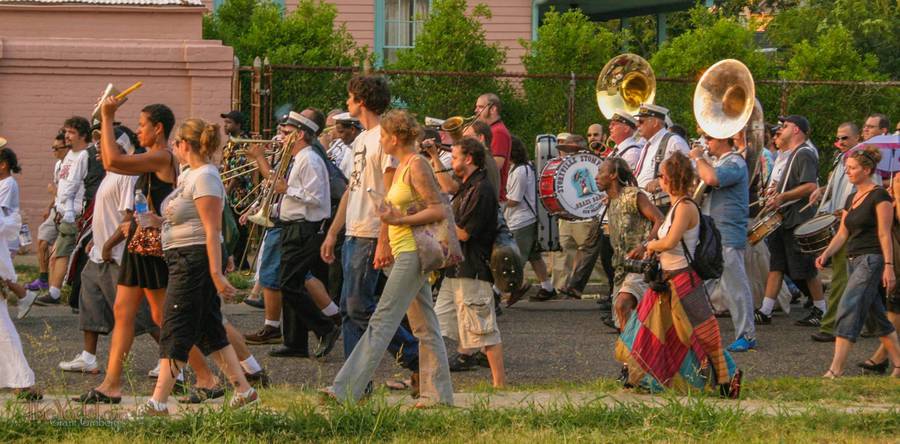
[519,9,620,141]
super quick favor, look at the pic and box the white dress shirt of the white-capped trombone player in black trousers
[279,147,331,222]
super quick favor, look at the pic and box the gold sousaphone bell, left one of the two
[595,53,656,119]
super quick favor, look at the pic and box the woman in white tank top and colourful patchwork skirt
[616,153,741,398]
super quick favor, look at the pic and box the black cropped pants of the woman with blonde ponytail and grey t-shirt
[159,245,228,362]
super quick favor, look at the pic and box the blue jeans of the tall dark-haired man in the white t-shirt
[341,236,419,370]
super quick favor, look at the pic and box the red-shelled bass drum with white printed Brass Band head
[538,152,605,220]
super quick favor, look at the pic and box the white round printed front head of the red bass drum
[547,152,604,219]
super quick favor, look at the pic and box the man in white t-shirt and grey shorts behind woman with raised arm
[59,137,159,373]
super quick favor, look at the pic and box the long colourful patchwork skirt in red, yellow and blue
[616,271,737,392]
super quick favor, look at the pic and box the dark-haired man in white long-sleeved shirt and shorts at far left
[34,117,91,305]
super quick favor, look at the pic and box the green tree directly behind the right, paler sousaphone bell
[650,18,778,133]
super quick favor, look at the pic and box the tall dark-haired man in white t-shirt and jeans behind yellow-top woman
[321,76,419,371]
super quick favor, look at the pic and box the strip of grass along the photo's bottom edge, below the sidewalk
[0,393,900,443]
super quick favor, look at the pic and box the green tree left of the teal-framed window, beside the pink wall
[204,0,366,119]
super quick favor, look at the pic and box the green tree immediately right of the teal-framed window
[387,0,514,121]
